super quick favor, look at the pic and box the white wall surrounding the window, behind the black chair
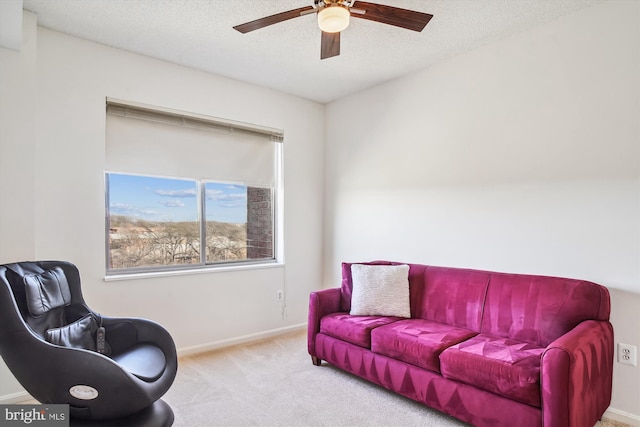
[0,13,324,397]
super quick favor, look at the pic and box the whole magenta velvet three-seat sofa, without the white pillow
[308,261,613,427]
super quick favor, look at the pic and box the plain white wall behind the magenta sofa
[325,1,640,421]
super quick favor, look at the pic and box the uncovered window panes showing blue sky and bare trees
[107,173,274,271]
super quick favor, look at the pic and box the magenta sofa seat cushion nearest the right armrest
[440,334,545,408]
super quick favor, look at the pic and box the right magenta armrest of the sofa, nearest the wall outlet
[540,320,613,427]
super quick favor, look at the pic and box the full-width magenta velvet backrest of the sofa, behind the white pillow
[340,261,611,347]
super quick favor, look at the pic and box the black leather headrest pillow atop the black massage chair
[23,267,71,317]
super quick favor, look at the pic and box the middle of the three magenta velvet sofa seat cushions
[371,319,477,372]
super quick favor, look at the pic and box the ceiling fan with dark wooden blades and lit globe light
[233,0,433,59]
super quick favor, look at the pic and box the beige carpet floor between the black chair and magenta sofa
[163,331,625,427]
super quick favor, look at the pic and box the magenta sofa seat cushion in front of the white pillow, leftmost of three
[320,313,401,348]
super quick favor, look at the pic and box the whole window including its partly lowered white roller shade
[105,100,282,274]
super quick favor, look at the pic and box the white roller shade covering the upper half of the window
[106,100,282,187]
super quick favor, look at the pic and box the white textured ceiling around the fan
[23,0,605,103]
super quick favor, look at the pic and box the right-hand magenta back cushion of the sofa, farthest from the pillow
[481,273,610,347]
